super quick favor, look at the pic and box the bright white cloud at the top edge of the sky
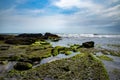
[53,0,102,11]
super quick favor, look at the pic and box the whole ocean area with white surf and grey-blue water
[51,33,120,51]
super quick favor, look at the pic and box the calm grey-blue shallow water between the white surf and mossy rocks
[51,37,120,51]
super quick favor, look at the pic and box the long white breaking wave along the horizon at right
[57,34,120,38]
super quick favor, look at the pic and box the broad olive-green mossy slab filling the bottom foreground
[6,53,109,80]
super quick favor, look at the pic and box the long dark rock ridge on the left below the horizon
[0,33,61,45]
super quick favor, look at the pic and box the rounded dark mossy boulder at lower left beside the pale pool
[14,62,32,70]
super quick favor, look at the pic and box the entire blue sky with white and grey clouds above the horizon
[0,0,120,34]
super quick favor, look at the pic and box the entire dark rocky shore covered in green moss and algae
[0,33,120,80]
